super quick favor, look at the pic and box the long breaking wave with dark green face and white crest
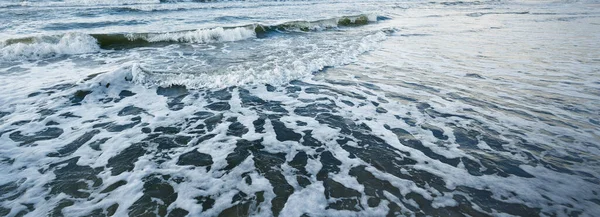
[0,15,386,60]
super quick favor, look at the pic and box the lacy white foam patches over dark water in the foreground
[1,73,598,216]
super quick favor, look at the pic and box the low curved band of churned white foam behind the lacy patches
[125,32,387,88]
